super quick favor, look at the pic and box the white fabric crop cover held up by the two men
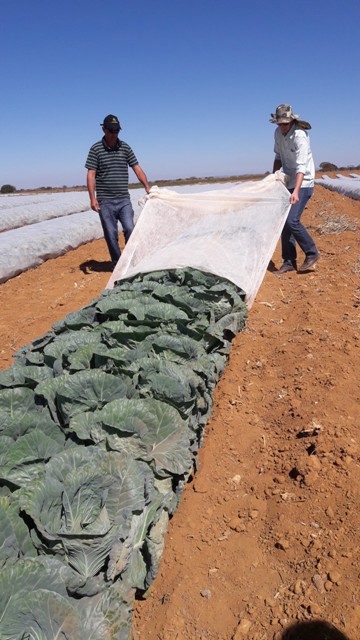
[107,172,290,307]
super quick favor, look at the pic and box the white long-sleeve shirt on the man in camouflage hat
[274,124,315,189]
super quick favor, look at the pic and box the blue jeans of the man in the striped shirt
[99,196,134,263]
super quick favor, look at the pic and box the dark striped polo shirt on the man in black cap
[85,137,139,202]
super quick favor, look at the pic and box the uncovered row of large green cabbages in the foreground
[0,268,246,640]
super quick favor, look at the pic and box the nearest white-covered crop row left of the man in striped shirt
[0,211,103,282]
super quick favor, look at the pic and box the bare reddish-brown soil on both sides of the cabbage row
[0,175,360,640]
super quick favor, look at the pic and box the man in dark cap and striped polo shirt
[85,114,150,267]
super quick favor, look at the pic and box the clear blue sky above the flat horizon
[0,0,360,189]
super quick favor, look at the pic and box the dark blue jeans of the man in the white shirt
[281,187,318,267]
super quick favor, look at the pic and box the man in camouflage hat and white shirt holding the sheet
[270,104,319,275]
